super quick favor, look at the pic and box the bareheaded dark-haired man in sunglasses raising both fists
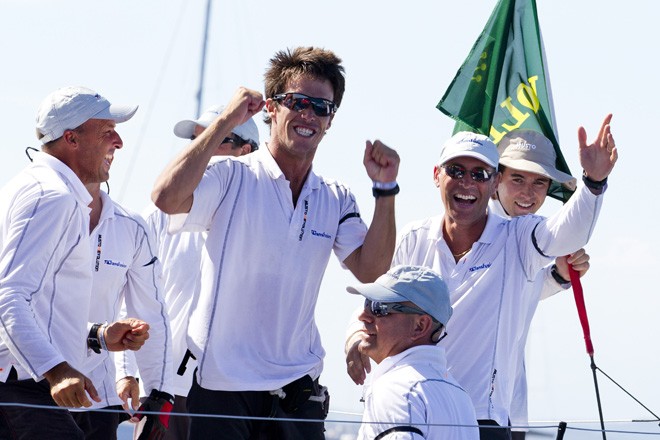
[152,47,399,440]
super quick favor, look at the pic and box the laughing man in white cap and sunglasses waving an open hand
[347,115,618,439]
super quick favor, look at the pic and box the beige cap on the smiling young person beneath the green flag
[497,130,577,191]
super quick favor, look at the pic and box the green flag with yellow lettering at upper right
[437,0,572,202]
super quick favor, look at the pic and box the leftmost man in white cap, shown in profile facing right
[0,87,149,439]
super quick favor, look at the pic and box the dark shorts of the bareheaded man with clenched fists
[188,379,329,440]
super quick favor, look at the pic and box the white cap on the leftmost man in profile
[37,86,138,144]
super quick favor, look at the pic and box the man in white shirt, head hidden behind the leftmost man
[73,177,173,440]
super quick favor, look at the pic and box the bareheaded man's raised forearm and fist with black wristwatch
[344,140,400,283]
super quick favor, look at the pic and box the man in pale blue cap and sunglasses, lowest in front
[346,266,479,440]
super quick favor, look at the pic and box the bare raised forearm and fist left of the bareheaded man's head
[151,87,264,214]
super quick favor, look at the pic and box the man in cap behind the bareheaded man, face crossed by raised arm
[135,105,259,440]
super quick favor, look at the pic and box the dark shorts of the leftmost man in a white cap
[0,375,85,440]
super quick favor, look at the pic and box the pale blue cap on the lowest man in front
[346,265,453,327]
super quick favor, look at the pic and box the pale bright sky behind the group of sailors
[0,0,660,430]
